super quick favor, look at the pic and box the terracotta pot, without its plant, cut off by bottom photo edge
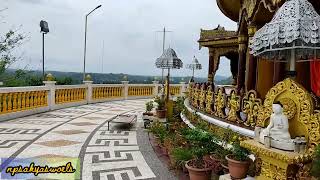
[186,161,212,180]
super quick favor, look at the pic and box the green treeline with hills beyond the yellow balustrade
[0,69,231,87]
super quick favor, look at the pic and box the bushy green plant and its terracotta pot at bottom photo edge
[185,128,217,180]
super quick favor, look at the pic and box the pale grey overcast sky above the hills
[0,0,237,77]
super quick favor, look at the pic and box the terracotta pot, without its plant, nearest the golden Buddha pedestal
[226,155,250,179]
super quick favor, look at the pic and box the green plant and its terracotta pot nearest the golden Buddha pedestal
[226,142,250,179]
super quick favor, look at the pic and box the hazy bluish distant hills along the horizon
[2,69,228,84]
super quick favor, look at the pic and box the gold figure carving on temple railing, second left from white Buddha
[227,90,240,122]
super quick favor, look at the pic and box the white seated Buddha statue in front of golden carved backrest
[260,102,293,147]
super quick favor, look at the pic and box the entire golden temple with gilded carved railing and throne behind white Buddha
[186,0,320,179]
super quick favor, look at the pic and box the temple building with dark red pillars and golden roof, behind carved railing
[198,0,320,97]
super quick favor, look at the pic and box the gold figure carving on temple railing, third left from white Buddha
[214,87,226,118]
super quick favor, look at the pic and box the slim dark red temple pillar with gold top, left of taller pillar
[237,36,248,94]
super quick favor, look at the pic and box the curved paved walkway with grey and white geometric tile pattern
[0,100,176,180]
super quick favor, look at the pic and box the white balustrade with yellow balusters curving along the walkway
[0,81,187,121]
